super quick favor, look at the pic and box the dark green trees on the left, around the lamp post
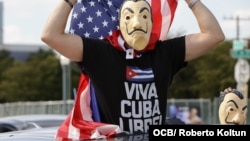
[0,50,79,103]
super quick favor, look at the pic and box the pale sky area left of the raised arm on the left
[3,0,59,44]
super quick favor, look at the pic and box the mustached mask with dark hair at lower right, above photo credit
[219,89,247,125]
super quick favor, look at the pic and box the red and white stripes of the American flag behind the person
[55,0,178,141]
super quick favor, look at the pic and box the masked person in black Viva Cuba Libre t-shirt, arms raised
[41,0,225,139]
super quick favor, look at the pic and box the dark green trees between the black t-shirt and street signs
[168,41,244,98]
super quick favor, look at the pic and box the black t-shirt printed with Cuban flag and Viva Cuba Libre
[80,36,186,133]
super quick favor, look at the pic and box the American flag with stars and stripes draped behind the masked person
[56,0,178,141]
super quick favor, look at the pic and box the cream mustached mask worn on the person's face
[119,0,152,51]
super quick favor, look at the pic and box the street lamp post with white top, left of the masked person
[60,55,70,114]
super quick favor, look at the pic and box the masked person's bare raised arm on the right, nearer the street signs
[185,0,225,61]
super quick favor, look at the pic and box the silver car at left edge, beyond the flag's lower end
[0,114,67,133]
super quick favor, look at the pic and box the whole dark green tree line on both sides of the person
[0,41,249,103]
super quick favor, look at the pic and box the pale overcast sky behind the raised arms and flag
[0,0,250,45]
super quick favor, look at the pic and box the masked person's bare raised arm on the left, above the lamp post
[41,0,83,61]
